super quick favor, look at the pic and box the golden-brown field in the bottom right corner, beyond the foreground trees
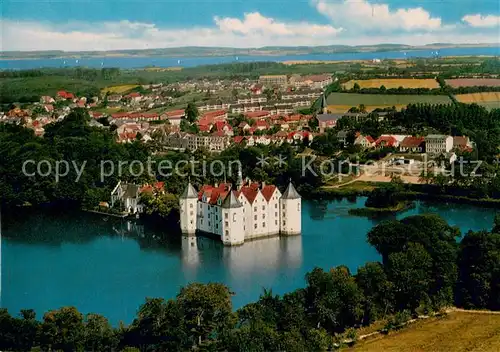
[345,312,500,352]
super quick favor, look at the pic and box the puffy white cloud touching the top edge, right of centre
[313,0,442,32]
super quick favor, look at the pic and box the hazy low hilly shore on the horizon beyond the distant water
[0,43,498,60]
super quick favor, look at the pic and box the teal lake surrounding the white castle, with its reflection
[0,198,495,325]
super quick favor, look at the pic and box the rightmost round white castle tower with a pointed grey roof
[280,181,302,236]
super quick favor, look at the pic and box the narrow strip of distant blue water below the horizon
[0,47,500,70]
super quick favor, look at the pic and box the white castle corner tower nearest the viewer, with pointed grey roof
[222,191,245,246]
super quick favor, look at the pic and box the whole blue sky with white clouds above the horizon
[0,0,500,51]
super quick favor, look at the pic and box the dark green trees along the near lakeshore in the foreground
[0,215,500,352]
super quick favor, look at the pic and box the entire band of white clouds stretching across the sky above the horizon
[0,5,498,51]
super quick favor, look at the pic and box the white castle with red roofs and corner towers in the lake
[179,173,302,246]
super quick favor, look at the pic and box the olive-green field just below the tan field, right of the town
[327,93,451,112]
